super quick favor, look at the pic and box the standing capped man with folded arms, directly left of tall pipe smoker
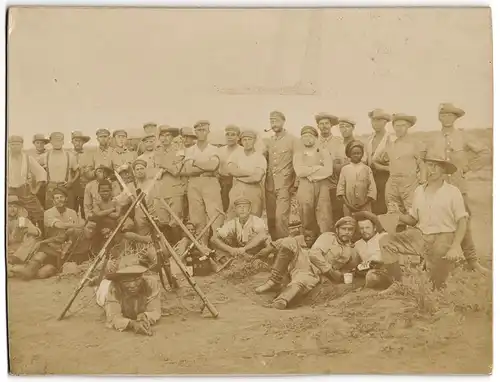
[227,130,267,218]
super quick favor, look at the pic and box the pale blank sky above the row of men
[8,8,493,146]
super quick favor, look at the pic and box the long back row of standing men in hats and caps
[8,104,489,286]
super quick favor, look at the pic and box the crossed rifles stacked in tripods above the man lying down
[58,170,219,320]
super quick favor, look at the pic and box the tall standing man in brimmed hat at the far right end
[428,103,491,274]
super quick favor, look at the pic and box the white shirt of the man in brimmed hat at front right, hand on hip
[410,182,468,235]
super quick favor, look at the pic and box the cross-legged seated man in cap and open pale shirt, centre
[211,197,269,266]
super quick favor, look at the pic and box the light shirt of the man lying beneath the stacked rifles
[104,276,161,332]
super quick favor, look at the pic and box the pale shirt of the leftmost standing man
[8,153,47,188]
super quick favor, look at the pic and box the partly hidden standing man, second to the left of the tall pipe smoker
[219,125,243,212]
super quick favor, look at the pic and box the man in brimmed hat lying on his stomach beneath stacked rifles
[97,265,161,336]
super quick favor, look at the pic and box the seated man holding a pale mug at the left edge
[7,195,41,274]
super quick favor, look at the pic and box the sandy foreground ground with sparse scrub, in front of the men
[8,176,492,374]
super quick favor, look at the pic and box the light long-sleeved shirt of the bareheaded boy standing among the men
[337,162,377,207]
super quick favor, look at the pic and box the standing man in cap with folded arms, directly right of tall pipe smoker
[293,126,333,236]
